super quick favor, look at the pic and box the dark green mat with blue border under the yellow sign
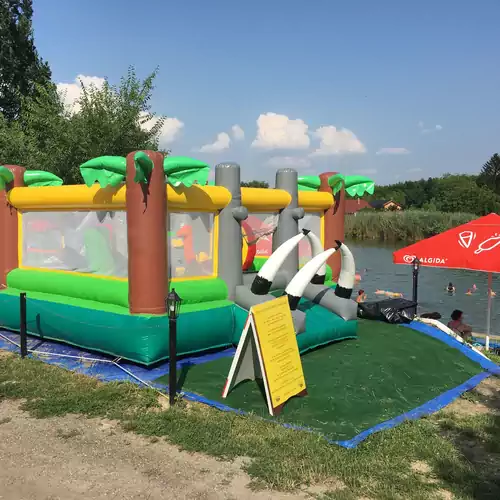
[157,320,483,441]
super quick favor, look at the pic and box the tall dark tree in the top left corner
[0,0,52,121]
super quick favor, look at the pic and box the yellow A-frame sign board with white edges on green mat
[222,296,307,416]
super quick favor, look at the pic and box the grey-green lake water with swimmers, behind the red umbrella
[346,241,500,335]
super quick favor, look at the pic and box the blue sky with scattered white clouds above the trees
[34,0,500,184]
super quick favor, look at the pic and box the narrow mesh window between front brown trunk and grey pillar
[167,212,214,278]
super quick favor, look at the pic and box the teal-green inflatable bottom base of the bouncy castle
[0,288,357,366]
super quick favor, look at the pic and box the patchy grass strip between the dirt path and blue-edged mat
[0,352,500,500]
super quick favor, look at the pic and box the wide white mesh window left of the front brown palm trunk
[20,211,128,278]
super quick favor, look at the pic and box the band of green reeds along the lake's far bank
[345,209,476,241]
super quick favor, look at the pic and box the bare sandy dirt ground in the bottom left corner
[0,401,310,500]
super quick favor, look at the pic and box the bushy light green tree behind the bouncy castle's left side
[0,68,168,184]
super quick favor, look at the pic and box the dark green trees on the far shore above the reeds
[370,174,500,215]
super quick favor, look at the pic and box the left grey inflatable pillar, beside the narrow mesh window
[215,163,248,300]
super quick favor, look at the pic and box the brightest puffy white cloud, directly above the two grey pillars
[252,112,310,149]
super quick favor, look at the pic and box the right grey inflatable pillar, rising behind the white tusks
[273,168,305,286]
